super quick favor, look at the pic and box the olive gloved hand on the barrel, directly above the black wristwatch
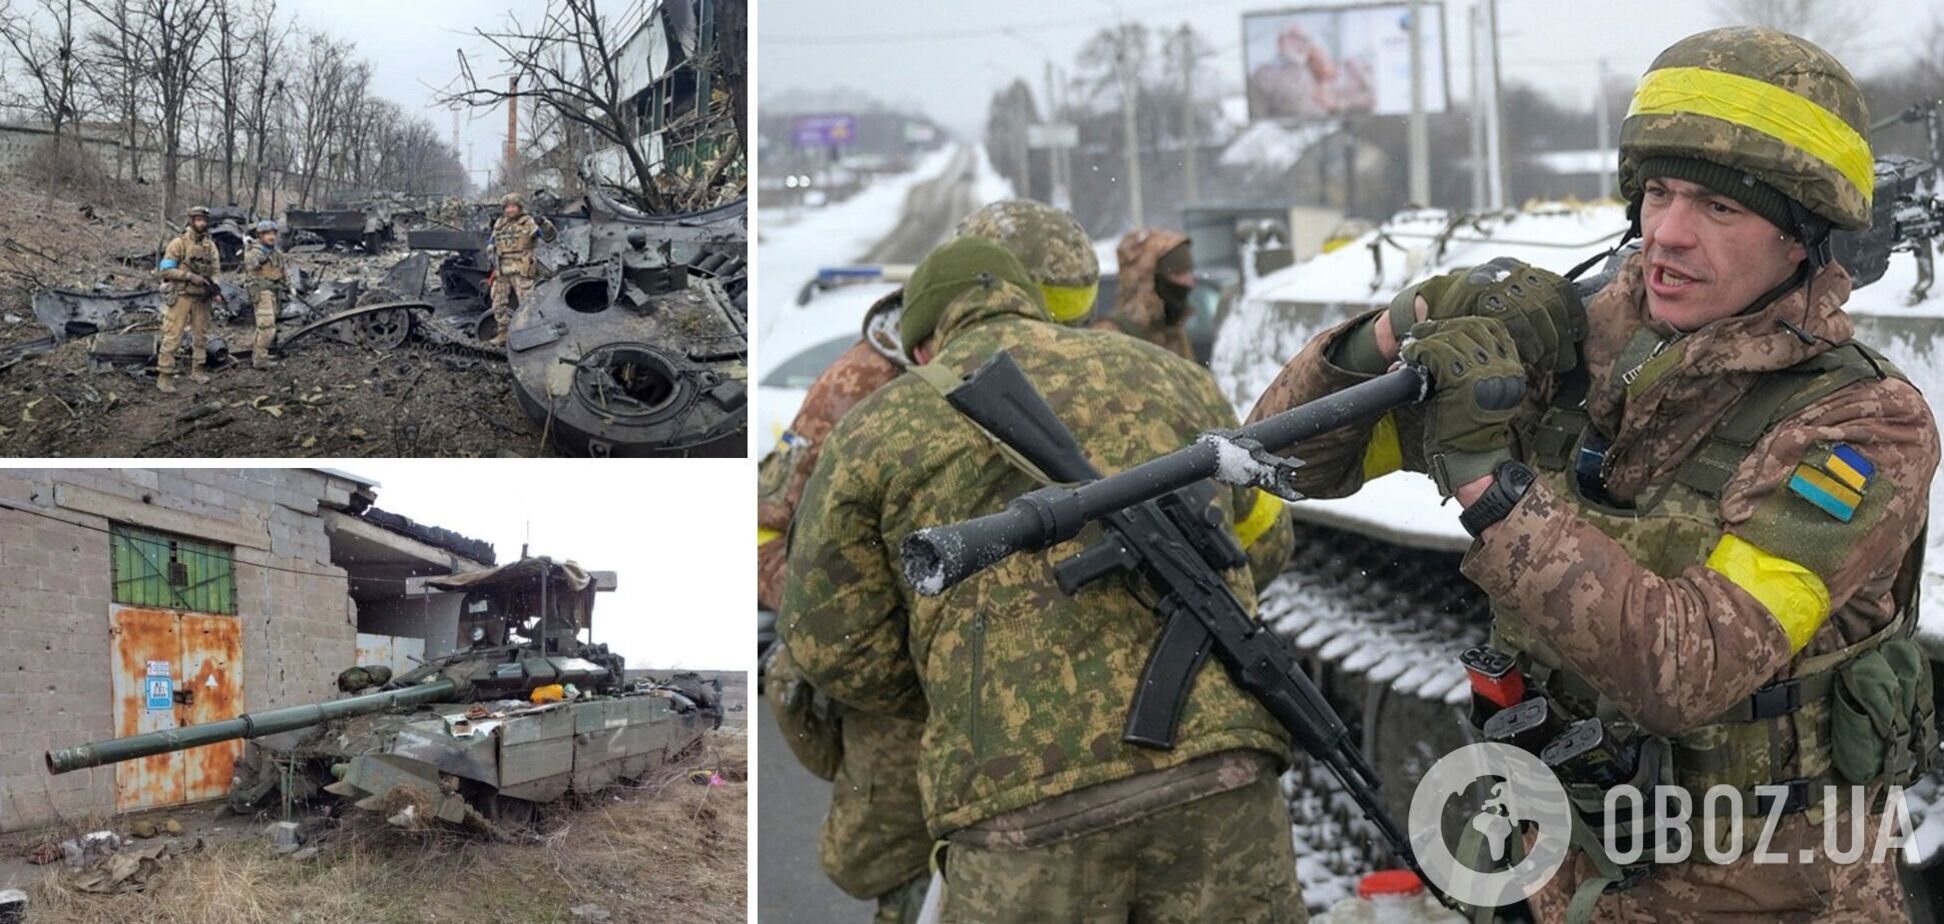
[1398,317,1526,498]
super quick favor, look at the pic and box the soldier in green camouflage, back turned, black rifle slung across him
[778,237,1304,922]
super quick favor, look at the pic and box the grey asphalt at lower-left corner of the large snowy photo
[750,702,877,924]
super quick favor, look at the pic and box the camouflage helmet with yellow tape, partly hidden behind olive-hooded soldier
[953,198,1100,323]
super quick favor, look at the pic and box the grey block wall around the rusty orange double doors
[0,469,358,831]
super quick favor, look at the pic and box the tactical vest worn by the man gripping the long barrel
[1493,335,1925,860]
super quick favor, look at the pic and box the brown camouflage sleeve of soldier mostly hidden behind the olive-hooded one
[756,340,904,609]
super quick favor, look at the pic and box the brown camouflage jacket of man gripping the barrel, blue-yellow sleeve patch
[1250,257,1938,735]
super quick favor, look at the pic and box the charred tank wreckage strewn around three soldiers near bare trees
[0,181,748,455]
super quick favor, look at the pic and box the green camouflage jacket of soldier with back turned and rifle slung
[778,286,1287,836]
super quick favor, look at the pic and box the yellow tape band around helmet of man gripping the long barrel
[1627,68,1876,208]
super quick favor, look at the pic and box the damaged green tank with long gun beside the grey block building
[47,556,723,831]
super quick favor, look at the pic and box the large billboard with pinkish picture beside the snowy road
[1242,2,1446,121]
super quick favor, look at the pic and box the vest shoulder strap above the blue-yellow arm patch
[1674,340,1909,500]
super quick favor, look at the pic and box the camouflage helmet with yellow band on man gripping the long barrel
[1619,25,1876,231]
